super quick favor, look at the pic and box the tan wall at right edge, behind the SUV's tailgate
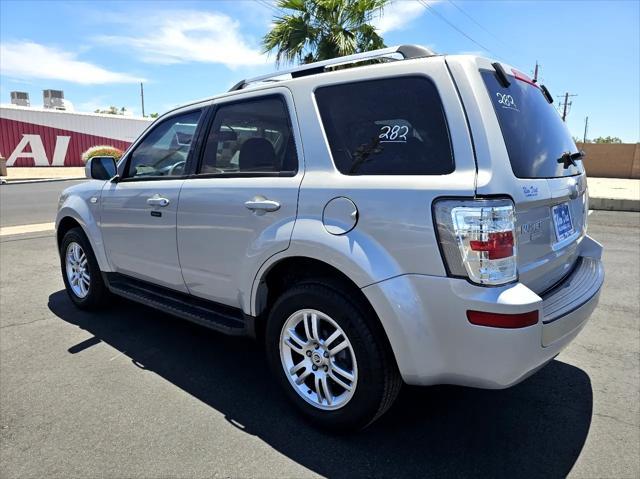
[577,143,640,179]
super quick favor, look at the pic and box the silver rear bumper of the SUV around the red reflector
[363,236,604,389]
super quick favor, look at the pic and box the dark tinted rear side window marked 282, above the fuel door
[315,77,454,175]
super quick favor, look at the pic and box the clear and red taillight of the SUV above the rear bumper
[435,199,518,285]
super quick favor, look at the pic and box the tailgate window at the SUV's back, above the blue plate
[481,70,582,178]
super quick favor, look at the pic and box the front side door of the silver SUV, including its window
[100,109,202,292]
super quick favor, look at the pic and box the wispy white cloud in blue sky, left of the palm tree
[97,10,267,68]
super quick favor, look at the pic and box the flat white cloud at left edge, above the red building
[0,41,143,85]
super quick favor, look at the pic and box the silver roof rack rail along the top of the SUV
[229,45,436,91]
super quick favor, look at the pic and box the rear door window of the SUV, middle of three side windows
[199,95,298,174]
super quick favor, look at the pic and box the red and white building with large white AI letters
[0,105,151,166]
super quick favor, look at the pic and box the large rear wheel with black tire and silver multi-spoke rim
[265,281,402,432]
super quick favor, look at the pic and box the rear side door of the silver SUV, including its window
[178,88,303,307]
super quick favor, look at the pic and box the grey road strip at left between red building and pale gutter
[0,180,87,227]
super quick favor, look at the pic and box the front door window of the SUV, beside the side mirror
[126,110,202,178]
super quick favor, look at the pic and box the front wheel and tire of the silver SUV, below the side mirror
[60,228,109,310]
